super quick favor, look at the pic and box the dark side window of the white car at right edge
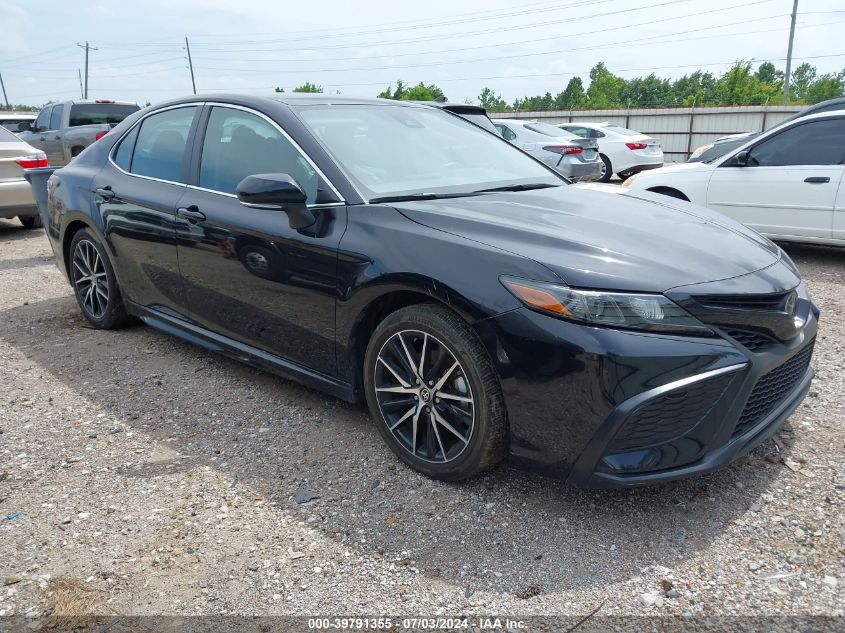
[748,119,845,167]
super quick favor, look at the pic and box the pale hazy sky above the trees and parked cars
[0,0,845,105]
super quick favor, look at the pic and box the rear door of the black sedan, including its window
[92,104,200,318]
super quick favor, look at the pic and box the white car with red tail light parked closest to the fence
[558,122,663,182]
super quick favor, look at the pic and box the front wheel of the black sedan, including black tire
[364,304,508,481]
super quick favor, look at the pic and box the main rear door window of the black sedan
[127,106,197,182]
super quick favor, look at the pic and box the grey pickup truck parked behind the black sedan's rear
[20,99,140,167]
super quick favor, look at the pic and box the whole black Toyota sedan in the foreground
[41,95,818,486]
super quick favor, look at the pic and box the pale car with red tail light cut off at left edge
[0,126,47,229]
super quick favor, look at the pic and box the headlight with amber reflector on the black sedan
[501,277,713,336]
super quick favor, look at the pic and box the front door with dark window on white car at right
[707,117,845,239]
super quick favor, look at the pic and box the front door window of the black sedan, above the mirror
[199,107,320,204]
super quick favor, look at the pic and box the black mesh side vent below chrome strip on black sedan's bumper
[609,375,732,453]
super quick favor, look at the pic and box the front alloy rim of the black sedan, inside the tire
[374,330,476,463]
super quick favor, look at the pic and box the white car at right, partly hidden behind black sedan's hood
[625,110,845,245]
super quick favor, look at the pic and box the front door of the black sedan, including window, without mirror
[178,106,346,375]
